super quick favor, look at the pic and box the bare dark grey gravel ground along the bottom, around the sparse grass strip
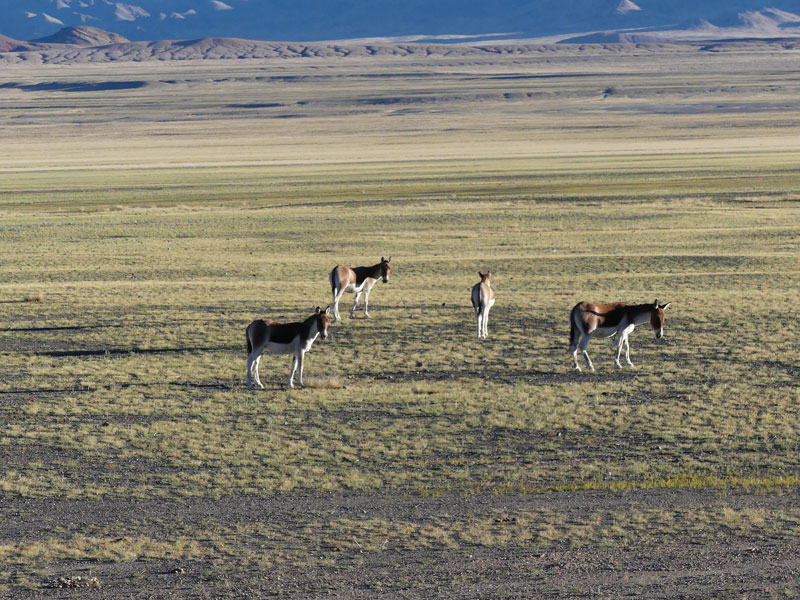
[0,490,800,598]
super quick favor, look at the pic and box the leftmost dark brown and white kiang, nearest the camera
[247,306,331,388]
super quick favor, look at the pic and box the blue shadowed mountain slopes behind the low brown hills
[0,0,800,41]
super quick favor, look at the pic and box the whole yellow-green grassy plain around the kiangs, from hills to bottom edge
[0,44,800,599]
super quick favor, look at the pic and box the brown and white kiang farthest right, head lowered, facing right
[569,300,671,371]
